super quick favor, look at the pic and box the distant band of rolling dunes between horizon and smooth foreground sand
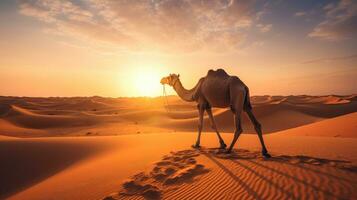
[0,95,357,137]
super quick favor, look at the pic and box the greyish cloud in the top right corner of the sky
[309,0,357,41]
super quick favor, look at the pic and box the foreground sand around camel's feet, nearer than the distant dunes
[0,133,357,199]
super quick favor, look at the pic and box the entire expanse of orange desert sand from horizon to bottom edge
[0,95,357,199]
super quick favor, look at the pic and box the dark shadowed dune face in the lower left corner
[0,137,114,199]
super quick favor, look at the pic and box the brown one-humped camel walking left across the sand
[160,69,270,157]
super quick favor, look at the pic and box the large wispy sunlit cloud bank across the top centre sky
[19,0,256,52]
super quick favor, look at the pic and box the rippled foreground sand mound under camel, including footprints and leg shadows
[105,148,357,200]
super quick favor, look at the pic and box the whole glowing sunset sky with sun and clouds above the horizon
[0,0,357,97]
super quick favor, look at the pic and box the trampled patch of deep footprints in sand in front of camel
[104,150,209,200]
